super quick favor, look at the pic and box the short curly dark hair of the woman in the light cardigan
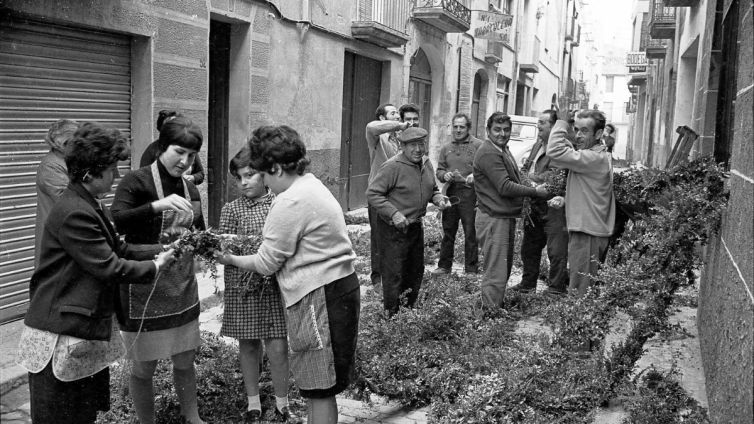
[249,125,309,175]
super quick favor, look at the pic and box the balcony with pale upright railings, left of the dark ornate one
[351,0,411,47]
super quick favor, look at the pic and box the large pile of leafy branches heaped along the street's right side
[357,158,727,423]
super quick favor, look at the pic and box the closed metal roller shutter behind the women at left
[0,14,131,323]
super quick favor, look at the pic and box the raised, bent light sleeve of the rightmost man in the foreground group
[547,120,604,174]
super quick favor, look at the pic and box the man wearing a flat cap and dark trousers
[367,127,449,315]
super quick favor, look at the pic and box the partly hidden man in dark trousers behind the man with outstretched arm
[512,109,568,294]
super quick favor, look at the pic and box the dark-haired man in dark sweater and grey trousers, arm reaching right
[473,112,547,308]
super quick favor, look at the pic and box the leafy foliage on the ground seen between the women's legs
[97,331,304,424]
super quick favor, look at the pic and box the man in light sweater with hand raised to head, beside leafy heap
[547,110,616,295]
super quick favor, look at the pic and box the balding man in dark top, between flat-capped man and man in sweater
[432,113,482,275]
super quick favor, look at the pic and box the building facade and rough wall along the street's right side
[627,0,754,423]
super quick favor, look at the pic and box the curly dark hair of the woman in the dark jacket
[65,122,131,182]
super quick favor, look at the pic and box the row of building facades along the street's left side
[0,0,581,322]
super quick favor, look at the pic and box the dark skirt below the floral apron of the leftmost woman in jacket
[29,360,110,424]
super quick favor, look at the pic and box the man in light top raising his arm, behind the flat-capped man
[366,103,409,284]
